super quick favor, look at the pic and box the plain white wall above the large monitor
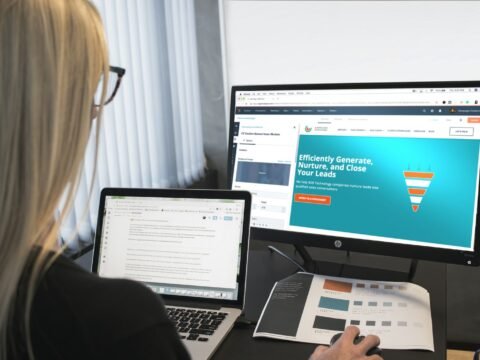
[219,0,480,119]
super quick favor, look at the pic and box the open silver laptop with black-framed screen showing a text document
[92,188,251,360]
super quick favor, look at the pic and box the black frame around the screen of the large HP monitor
[227,80,480,266]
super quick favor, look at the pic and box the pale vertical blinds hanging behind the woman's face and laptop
[61,0,205,250]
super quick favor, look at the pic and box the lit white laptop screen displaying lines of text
[98,196,245,300]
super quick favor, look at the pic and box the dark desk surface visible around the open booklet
[213,250,446,360]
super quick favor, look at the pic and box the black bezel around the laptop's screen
[92,188,252,309]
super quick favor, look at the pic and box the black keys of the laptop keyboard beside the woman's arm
[167,307,228,342]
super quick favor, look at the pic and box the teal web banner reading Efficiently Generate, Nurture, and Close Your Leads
[290,135,479,248]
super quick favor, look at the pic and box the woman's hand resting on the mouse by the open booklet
[309,326,383,360]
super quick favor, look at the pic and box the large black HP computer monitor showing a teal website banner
[229,81,480,265]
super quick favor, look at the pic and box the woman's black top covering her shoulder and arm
[20,256,189,360]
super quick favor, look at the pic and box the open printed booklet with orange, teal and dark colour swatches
[253,272,434,351]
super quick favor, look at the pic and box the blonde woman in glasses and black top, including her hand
[0,0,382,360]
